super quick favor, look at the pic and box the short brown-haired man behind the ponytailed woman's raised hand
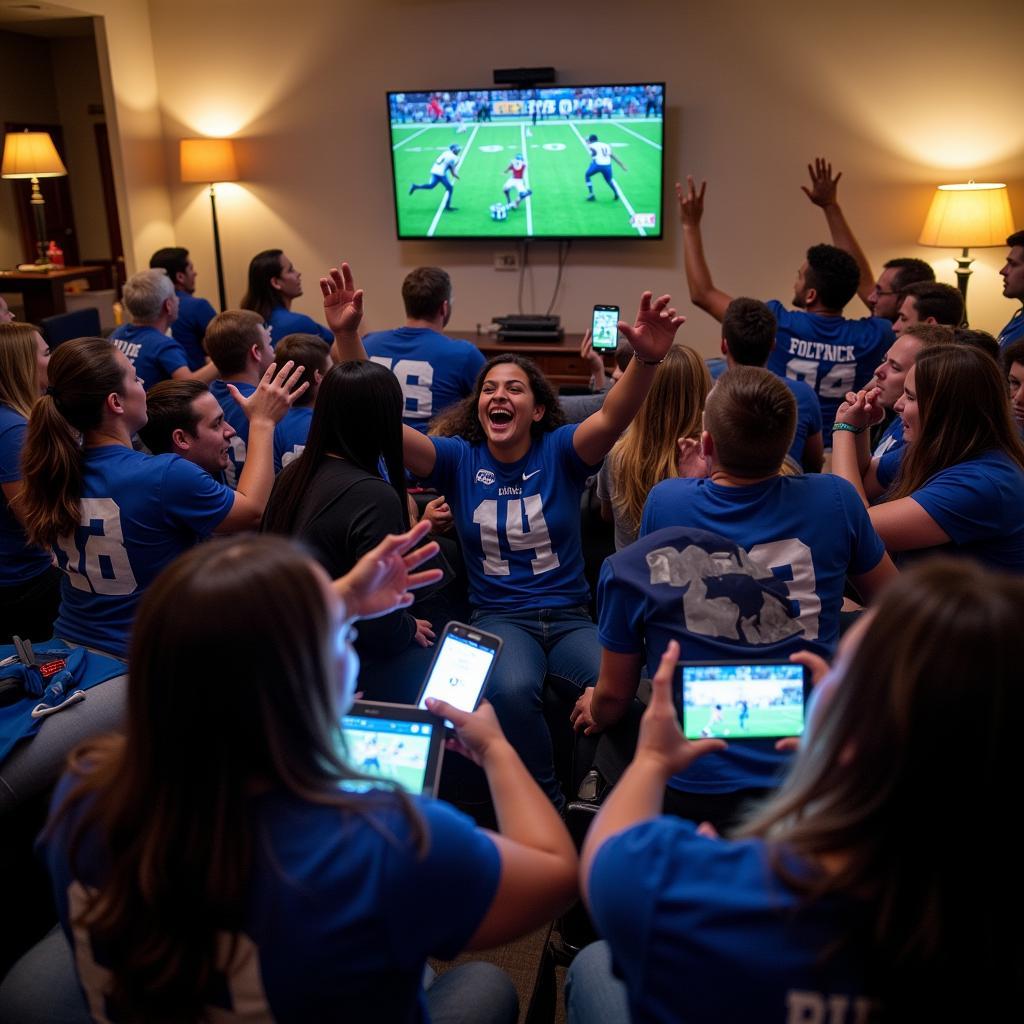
[205,309,274,487]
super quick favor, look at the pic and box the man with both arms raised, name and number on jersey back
[676,177,893,434]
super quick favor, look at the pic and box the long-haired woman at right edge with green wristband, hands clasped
[833,345,1024,572]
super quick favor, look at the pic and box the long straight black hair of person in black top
[263,359,409,535]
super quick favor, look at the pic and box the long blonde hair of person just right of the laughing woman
[609,345,711,529]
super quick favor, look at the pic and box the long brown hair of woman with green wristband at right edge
[886,344,1024,499]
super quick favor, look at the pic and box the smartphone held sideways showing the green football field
[676,662,811,742]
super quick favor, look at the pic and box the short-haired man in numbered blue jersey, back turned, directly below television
[358,266,485,433]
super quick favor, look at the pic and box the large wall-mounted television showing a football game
[387,83,665,239]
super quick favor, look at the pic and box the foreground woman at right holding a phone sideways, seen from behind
[566,559,1024,1024]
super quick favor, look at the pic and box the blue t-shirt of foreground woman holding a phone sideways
[590,816,877,1024]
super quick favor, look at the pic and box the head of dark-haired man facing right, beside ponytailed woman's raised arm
[138,380,235,480]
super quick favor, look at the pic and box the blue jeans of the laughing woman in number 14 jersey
[471,607,601,808]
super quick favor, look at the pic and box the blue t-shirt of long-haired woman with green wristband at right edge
[876,447,1024,572]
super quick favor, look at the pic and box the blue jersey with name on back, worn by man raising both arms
[766,299,895,434]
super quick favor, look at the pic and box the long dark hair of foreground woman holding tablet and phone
[50,536,425,1022]
